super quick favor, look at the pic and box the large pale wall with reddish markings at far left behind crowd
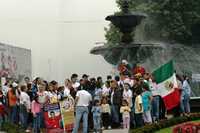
[0,43,32,81]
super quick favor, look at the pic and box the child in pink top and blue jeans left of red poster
[31,95,41,133]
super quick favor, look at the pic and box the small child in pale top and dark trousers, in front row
[101,97,111,129]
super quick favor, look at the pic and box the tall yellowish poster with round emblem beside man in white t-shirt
[60,96,74,131]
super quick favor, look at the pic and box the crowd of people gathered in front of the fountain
[0,60,191,133]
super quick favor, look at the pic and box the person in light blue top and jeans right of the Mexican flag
[181,75,191,115]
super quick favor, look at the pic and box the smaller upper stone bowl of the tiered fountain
[106,12,147,33]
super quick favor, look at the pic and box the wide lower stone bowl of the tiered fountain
[90,43,162,65]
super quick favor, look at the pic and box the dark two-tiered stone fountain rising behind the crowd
[90,0,161,65]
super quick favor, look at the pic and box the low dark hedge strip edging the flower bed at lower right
[130,113,200,133]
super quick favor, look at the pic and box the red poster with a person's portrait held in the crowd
[44,103,62,129]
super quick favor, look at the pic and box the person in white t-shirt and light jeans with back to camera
[73,85,92,133]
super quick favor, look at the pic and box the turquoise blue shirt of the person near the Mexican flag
[142,91,152,112]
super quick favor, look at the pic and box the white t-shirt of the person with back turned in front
[76,90,92,107]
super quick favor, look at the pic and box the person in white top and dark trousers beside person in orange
[19,85,31,129]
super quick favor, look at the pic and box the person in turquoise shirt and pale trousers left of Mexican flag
[142,83,153,124]
